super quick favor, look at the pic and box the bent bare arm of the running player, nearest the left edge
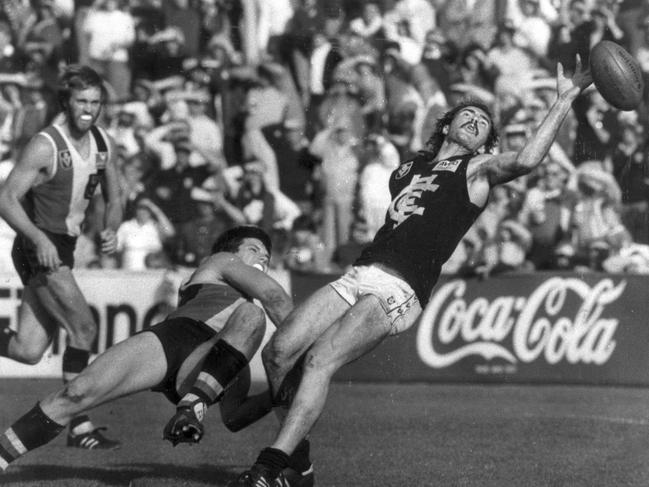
[0,136,60,269]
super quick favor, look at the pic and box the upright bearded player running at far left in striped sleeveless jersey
[0,65,122,449]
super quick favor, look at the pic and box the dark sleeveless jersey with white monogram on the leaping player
[354,152,484,306]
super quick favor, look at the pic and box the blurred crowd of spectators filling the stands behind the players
[0,0,649,277]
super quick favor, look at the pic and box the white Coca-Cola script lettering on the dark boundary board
[417,277,627,368]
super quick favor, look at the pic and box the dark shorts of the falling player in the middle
[140,317,216,404]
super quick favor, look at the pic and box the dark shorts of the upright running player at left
[11,230,77,285]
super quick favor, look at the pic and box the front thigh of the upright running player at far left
[34,266,94,331]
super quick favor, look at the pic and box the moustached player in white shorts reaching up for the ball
[230,59,592,487]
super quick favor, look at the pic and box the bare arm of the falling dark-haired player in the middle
[212,252,293,326]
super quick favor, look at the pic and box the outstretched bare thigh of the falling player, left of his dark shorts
[70,332,167,406]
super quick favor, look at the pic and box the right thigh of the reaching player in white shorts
[304,294,392,374]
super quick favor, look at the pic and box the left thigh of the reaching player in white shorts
[270,285,350,362]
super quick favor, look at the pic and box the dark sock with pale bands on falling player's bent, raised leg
[178,340,248,407]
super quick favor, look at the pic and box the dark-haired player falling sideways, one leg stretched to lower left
[0,226,310,485]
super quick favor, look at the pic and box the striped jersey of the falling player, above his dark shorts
[167,283,249,331]
